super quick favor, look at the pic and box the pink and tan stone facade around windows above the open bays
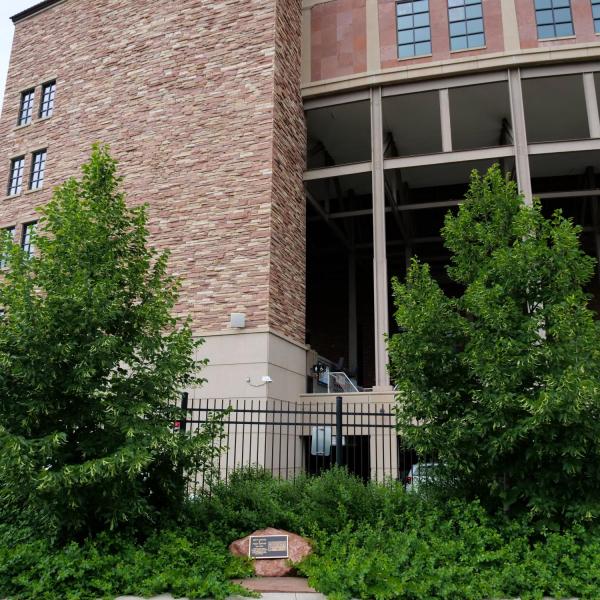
[303,0,600,86]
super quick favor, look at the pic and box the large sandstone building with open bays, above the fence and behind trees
[0,0,600,408]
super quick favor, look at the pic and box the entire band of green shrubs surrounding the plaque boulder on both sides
[0,469,600,600]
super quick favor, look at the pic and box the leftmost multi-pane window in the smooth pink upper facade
[396,0,431,58]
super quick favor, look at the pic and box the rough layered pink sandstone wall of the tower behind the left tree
[0,0,304,342]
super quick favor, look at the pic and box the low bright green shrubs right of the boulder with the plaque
[300,494,600,600]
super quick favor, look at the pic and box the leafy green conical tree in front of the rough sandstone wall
[0,146,222,538]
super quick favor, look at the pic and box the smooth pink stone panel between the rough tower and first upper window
[311,0,367,81]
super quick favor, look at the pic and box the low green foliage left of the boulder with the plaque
[0,530,252,600]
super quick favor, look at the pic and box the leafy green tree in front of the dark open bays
[388,166,600,522]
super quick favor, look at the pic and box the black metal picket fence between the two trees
[182,395,416,493]
